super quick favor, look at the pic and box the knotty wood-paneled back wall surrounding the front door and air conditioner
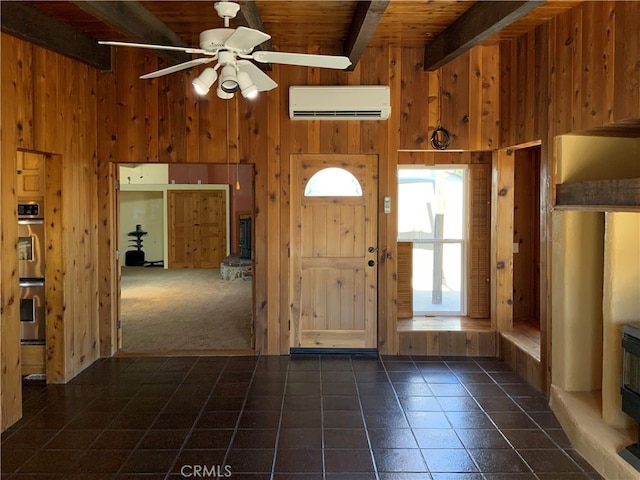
[98,47,499,360]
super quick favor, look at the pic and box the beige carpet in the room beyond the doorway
[120,267,252,352]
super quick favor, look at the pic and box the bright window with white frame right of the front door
[398,166,467,315]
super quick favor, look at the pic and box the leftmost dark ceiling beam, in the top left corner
[0,2,111,70]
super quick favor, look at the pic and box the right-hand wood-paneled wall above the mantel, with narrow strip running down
[500,1,640,388]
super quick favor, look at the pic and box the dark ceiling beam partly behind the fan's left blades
[71,0,192,64]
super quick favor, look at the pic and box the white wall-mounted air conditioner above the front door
[289,85,391,120]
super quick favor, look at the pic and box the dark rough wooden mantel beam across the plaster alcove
[556,178,640,211]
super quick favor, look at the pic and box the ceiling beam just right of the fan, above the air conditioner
[344,0,389,70]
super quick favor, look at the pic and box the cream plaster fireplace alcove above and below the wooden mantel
[550,130,640,478]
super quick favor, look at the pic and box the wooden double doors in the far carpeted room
[167,190,227,268]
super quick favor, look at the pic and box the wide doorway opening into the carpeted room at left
[117,164,254,354]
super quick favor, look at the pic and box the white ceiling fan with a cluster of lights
[99,1,351,99]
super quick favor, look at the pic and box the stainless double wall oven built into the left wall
[18,201,46,344]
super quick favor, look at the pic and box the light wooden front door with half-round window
[290,155,378,349]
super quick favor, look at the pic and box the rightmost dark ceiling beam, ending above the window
[424,0,545,72]
